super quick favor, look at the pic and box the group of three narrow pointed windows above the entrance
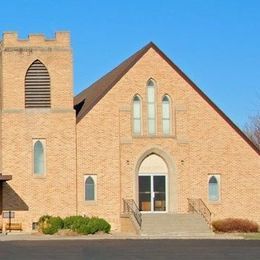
[132,79,172,135]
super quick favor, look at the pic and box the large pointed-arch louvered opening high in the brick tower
[25,60,51,108]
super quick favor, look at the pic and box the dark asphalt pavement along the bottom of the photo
[0,240,260,260]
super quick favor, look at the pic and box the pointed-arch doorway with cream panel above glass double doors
[138,153,168,212]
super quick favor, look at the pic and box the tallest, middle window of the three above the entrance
[147,79,156,135]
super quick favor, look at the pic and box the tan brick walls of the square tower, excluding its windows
[1,33,76,230]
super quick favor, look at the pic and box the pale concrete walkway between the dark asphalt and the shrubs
[0,232,244,241]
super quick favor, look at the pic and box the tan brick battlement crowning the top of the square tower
[0,32,70,48]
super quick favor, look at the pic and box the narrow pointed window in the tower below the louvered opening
[33,140,45,176]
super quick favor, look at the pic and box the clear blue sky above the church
[0,0,260,127]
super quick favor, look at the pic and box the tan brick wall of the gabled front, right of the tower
[77,46,260,228]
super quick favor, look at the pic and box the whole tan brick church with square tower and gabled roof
[0,32,260,231]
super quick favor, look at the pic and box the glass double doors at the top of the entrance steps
[138,174,166,212]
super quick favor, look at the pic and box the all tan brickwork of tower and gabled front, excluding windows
[0,33,260,230]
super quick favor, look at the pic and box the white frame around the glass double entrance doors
[137,173,169,214]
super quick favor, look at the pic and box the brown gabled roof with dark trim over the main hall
[74,42,260,155]
